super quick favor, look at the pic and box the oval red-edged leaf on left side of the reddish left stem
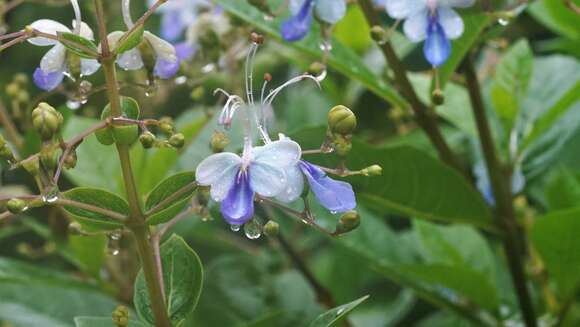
[62,187,129,230]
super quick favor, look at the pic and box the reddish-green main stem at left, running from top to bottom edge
[95,0,171,327]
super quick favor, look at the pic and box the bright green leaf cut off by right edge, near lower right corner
[531,208,580,297]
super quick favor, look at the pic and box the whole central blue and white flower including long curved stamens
[196,38,356,225]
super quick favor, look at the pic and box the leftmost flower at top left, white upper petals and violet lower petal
[28,0,100,91]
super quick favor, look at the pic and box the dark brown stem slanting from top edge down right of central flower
[358,0,466,174]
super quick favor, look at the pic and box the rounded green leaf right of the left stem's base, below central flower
[134,235,203,325]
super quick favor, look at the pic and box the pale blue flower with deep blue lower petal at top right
[386,0,475,67]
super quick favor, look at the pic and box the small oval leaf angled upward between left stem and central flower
[145,172,196,225]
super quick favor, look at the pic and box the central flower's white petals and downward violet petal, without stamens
[195,140,302,225]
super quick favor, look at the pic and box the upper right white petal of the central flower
[252,139,302,167]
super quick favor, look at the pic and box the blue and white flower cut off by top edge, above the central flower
[281,0,346,42]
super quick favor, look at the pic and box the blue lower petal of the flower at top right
[423,15,451,67]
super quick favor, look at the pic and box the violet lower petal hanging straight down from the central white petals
[221,171,254,225]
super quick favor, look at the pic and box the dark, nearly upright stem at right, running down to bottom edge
[464,56,537,327]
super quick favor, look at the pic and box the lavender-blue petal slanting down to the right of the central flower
[299,160,356,212]
